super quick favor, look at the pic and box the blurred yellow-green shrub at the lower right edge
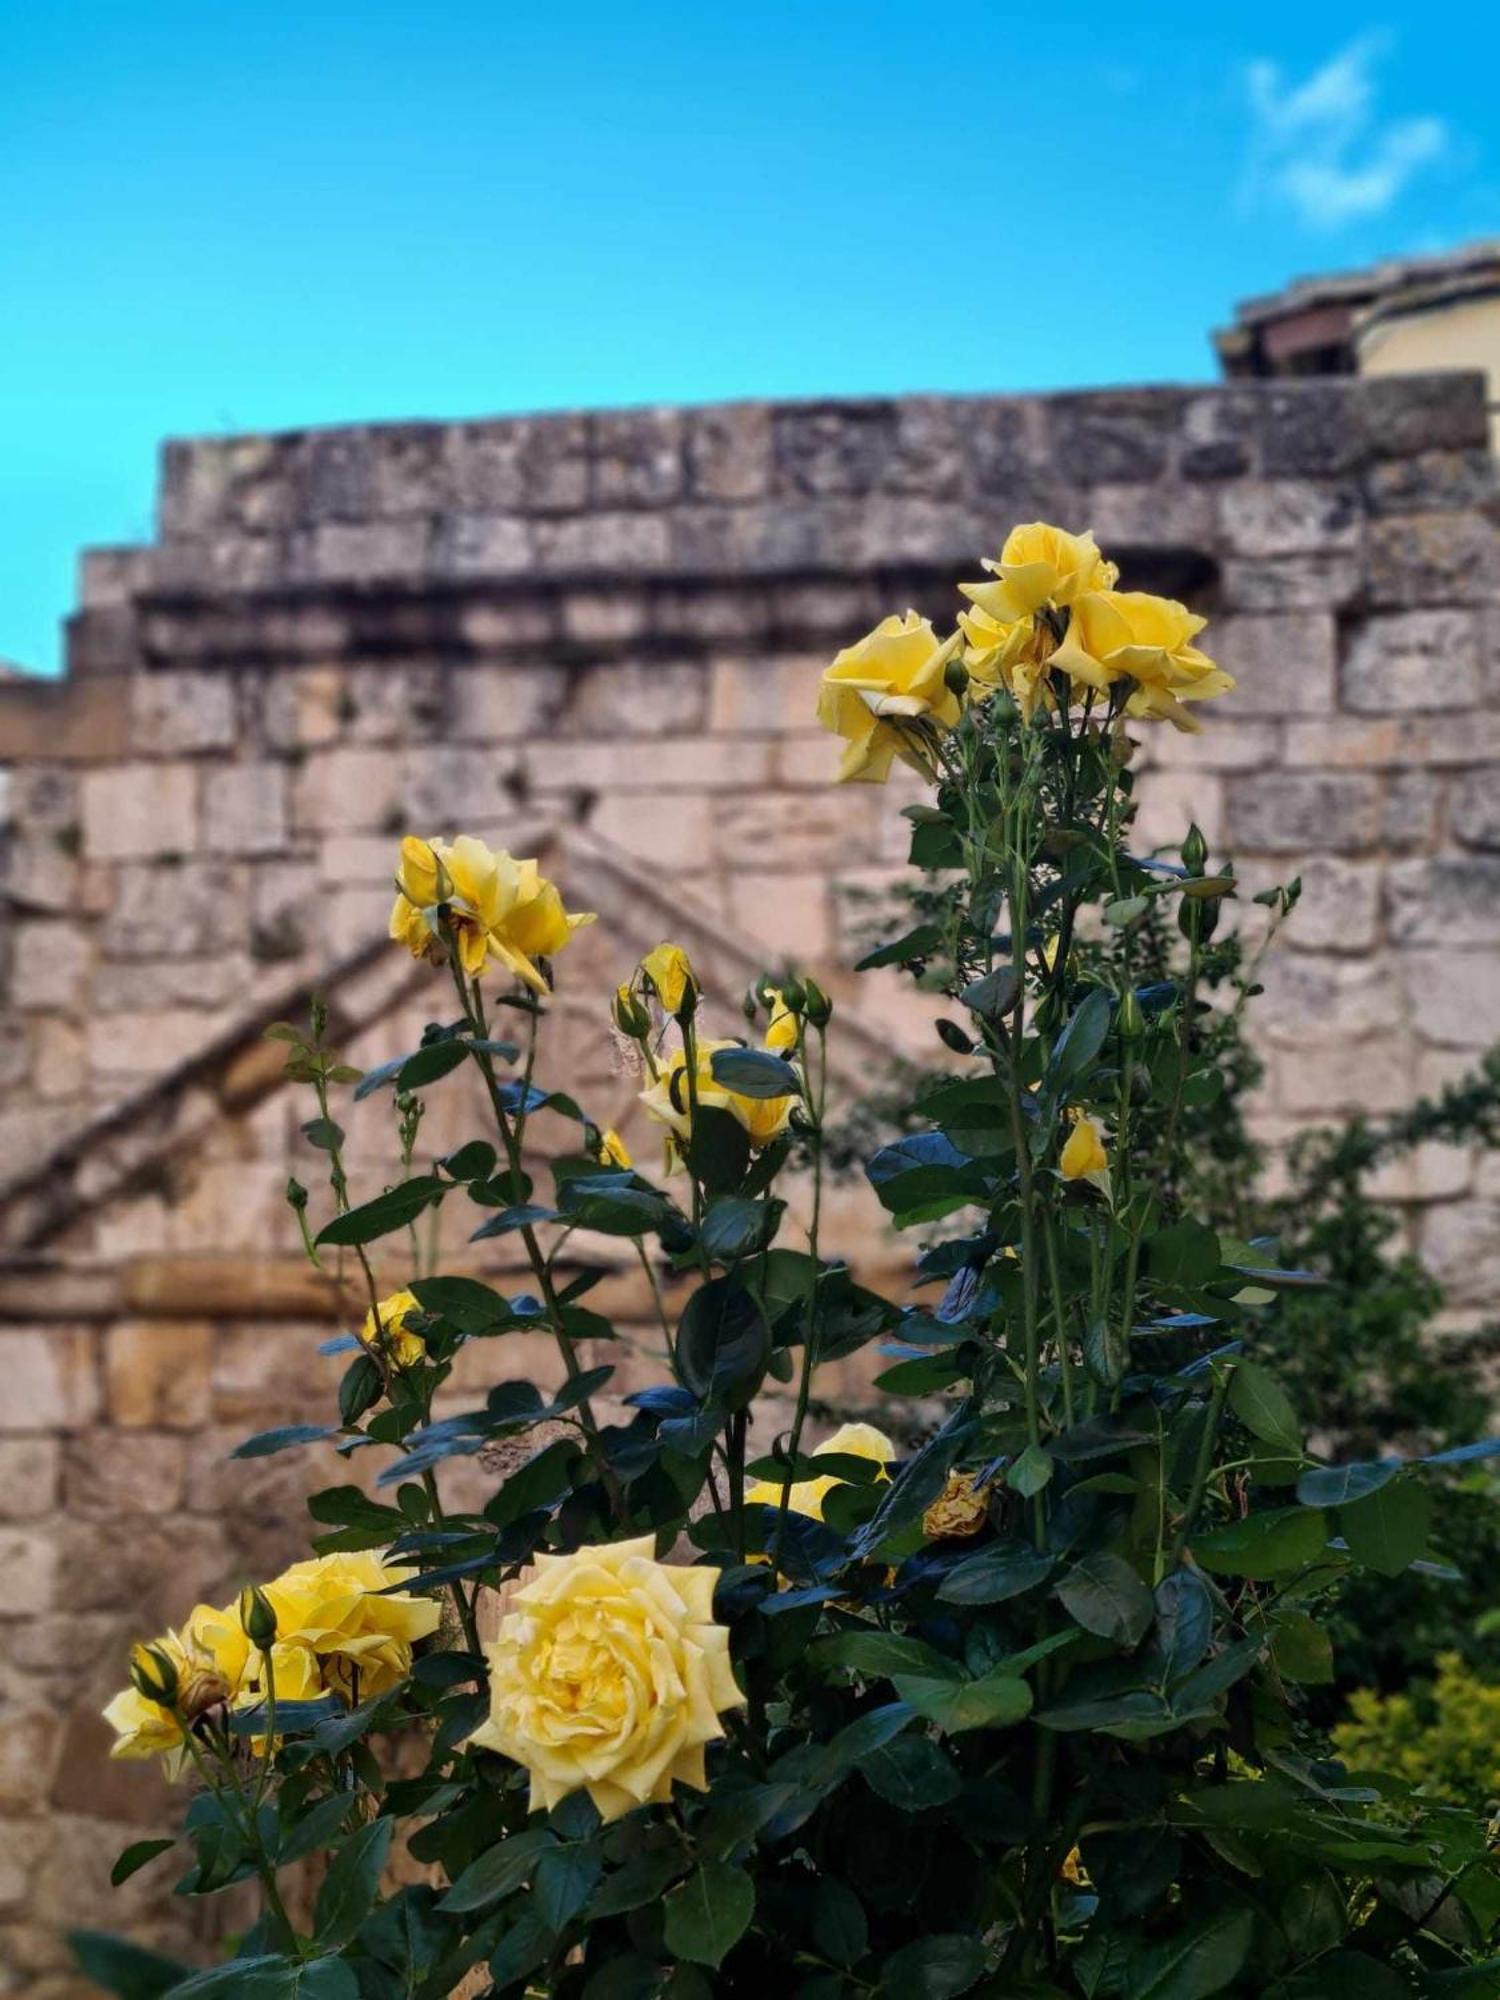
[1334,1652,1500,1808]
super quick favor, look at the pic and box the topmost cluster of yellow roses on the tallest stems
[818,520,1234,784]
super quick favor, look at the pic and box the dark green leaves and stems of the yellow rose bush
[85,614,1500,2000]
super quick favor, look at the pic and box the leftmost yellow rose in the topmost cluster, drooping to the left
[818,612,962,784]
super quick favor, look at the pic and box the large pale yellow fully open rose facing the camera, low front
[470,1536,744,1820]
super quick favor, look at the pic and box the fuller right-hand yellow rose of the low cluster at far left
[266,1550,440,1700]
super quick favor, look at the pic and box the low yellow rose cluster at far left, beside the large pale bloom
[104,1550,440,1772]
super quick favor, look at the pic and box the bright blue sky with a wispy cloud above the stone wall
[0,0,1500,670]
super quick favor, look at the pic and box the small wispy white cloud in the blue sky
[1240,34,1452,230]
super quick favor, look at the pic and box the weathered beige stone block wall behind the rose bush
[0,376,1500,1996]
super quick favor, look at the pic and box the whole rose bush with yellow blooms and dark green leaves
[78,524,1500,2000]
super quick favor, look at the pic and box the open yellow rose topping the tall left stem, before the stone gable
[390,834,594,992]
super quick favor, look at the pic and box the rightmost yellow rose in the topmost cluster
[1052,590,1234,730]
